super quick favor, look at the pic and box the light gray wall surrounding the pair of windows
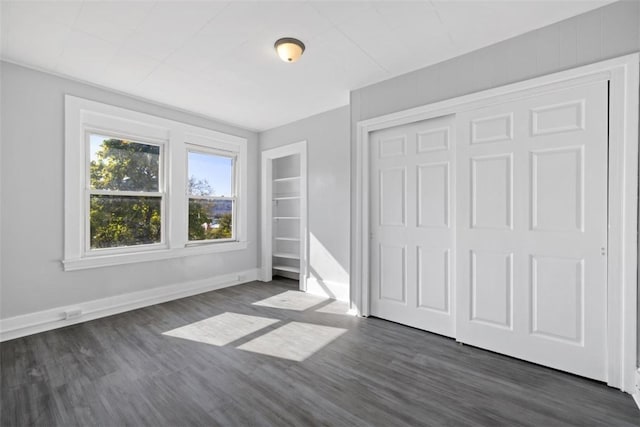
[0,62,258,319]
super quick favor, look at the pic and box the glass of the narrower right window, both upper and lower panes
[187,150,235,241]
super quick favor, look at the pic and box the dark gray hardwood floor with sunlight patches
[0,280,640,426]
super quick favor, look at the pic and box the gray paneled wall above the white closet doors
[350,0,640,362]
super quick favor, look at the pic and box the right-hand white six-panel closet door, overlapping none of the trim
[456,82,608,380]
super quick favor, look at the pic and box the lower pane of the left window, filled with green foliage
[90,194,162,249]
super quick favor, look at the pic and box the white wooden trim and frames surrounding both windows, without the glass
[62,95,248,271]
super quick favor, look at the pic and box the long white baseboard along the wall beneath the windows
[0,268,260,342]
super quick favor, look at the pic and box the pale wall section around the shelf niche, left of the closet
[259,106,350,300]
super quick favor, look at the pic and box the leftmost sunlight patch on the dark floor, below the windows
[162,313,279,346]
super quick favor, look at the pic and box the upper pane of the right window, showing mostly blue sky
[189,151,233,197]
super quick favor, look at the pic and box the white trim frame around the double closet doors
[351,53,640,393]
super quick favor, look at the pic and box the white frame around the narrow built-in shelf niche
[260,141,309,292]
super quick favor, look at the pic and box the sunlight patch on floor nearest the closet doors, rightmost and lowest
[238,322,347,362]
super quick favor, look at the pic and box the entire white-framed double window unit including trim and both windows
[63,96,247,270]
